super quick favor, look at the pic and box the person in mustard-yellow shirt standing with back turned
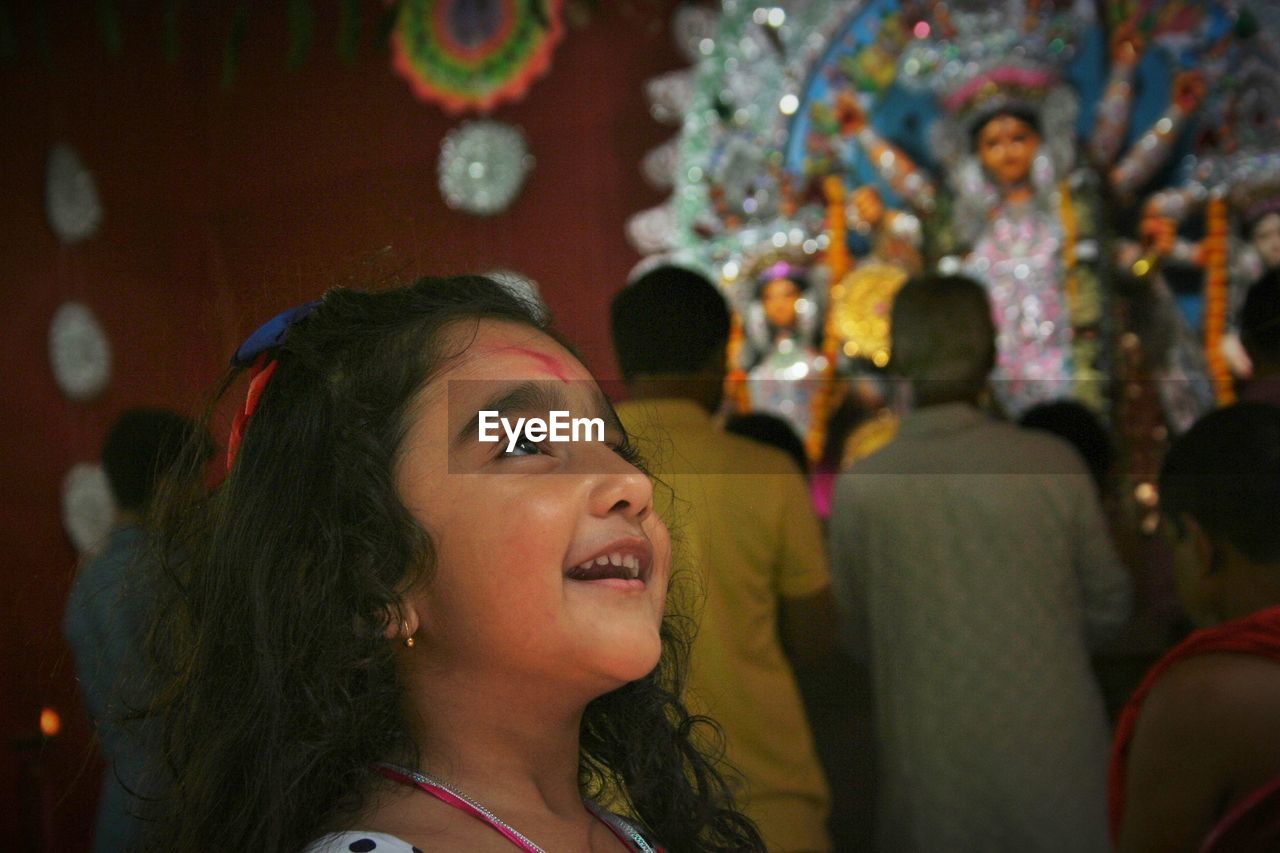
[611,266,836,853]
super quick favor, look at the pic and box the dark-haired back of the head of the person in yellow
[609,266,730,380]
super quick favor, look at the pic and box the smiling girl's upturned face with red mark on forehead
[396,320,671,695]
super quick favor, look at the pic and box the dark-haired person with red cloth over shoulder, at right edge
[1110,403,1280,853]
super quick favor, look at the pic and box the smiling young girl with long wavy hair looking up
[145,278,763,853]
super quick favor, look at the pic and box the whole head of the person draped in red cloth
[1160,403,1280,624]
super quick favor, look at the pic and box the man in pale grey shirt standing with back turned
[831,277,1130,853]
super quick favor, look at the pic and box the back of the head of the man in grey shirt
[890,275,996,405]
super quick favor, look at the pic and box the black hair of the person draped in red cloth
[1160,403,1280,565]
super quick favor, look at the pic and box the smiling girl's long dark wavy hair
[142,277,763,850]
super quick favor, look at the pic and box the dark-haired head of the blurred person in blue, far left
[102,409,212,511]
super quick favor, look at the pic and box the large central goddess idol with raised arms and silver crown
[837,0,1223,416]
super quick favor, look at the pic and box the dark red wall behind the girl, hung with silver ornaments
[0,0,682,850]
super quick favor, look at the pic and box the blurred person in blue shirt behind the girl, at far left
[63,409,212,853]
